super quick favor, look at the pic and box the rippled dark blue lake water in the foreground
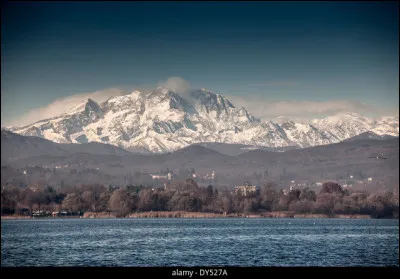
[1,218,399,266]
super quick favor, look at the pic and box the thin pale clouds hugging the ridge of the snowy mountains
[2,77,399,126]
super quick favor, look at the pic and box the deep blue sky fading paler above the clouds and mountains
[1,2,399,125]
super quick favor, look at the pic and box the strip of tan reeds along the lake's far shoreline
[1,211,376,220]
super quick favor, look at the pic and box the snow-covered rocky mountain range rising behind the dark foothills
[9,87,399,152]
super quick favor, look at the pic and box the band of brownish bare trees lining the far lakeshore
[1,179,399,218]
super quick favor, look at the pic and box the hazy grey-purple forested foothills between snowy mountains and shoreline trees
[1,131,399,192]
